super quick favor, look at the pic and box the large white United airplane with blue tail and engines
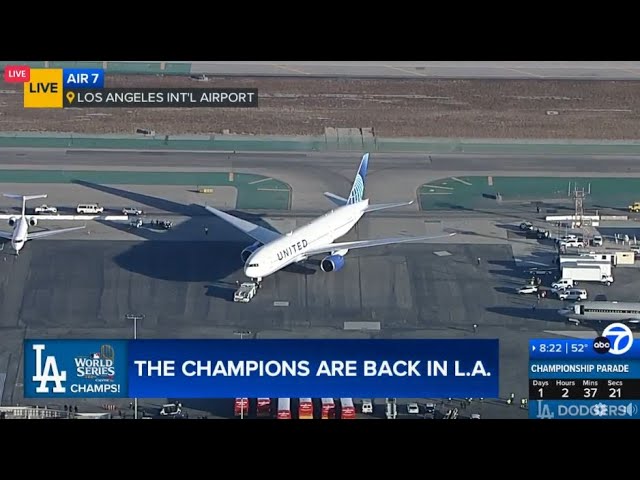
[204,153,455,286]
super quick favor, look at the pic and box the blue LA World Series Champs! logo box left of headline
[25,340,125,398]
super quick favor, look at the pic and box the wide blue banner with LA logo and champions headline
[25,340,499,399]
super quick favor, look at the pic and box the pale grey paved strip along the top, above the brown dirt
[184,61,640,80]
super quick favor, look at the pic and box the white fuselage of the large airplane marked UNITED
[244,199,369,279]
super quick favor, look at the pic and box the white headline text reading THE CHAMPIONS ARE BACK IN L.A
[133,360,492,377]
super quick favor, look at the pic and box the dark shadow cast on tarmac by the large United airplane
[73,180,319,301]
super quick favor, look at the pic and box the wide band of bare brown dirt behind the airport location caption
[0,76,640,140]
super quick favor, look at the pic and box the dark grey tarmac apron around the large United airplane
[6,151,637,418]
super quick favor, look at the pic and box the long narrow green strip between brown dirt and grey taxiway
[0,132,640,155]
